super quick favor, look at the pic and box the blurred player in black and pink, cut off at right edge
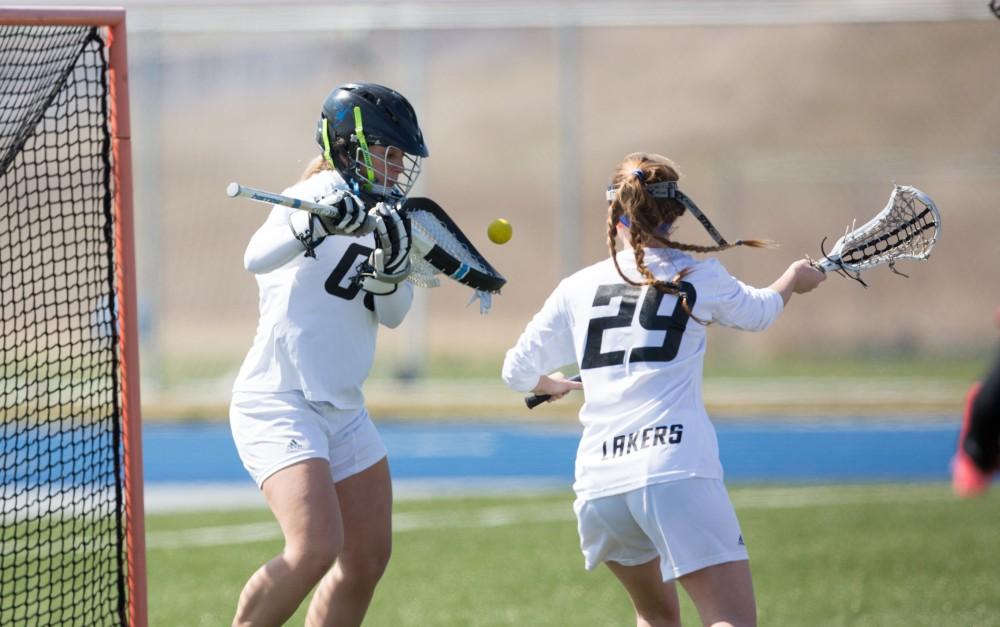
[951,307,1000,497]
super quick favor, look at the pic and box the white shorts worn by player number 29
[573,478,749,581]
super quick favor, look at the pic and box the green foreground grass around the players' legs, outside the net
[147,484,1000,627]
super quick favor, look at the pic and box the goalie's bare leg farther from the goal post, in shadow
[306,458,392,627]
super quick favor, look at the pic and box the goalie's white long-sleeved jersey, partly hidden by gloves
[233,170,413,409]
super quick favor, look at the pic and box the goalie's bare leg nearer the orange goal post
[233,459,344,627]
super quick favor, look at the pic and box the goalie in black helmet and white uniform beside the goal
[230,83,428,626]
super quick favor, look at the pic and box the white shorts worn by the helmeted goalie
[229,391,386,487]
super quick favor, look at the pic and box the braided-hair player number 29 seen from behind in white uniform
[503,153,825,625]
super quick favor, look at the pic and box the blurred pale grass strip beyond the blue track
[143,345,995,423]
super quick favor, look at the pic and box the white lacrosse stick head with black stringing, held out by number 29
[816,185,941,284]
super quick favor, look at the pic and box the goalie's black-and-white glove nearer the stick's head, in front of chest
[356,203,413,295]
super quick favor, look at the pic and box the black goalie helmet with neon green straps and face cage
[316,83,428,203]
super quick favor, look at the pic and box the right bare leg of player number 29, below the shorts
[679,560,757,627]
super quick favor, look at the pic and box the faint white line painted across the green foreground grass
[146,485,953,550]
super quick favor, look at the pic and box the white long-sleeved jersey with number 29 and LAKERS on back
[503,248,784,499]
